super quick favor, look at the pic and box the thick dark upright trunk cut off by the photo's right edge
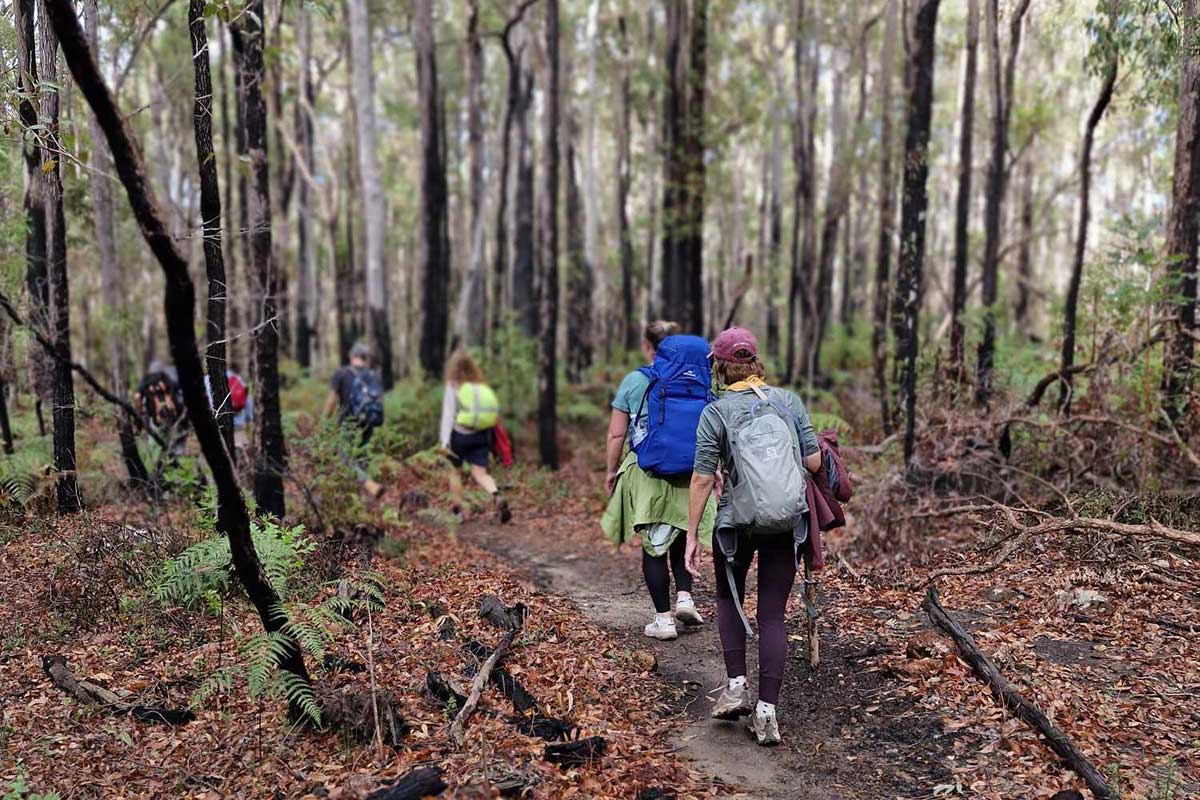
[1163,0,1200,422]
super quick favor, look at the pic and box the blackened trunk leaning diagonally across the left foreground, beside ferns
[47,0,312,715]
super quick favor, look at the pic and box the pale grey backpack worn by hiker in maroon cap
[716,386,809,533]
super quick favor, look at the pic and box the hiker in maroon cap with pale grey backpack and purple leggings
[686,327,821,745]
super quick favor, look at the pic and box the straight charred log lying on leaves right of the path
[923,587,1118,800]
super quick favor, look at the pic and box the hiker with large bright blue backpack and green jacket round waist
[600,321,713,640]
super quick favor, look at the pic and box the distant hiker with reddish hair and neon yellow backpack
[438,350,512,524]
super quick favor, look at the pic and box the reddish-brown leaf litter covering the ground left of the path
[0,510,716,799]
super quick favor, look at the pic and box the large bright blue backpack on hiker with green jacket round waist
[632,336,713,477]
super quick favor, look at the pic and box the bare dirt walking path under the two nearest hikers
[460,513,953,800]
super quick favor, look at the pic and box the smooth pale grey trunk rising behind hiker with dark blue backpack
[347,0,393,389]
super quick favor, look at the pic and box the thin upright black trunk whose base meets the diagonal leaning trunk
[187,0,234,452]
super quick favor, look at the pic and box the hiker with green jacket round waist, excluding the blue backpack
[600,320,713,640]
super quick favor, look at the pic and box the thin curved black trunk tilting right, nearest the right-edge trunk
[1058,14,1120,414]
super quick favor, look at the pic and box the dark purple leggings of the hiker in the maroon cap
[713,533,796,703]
